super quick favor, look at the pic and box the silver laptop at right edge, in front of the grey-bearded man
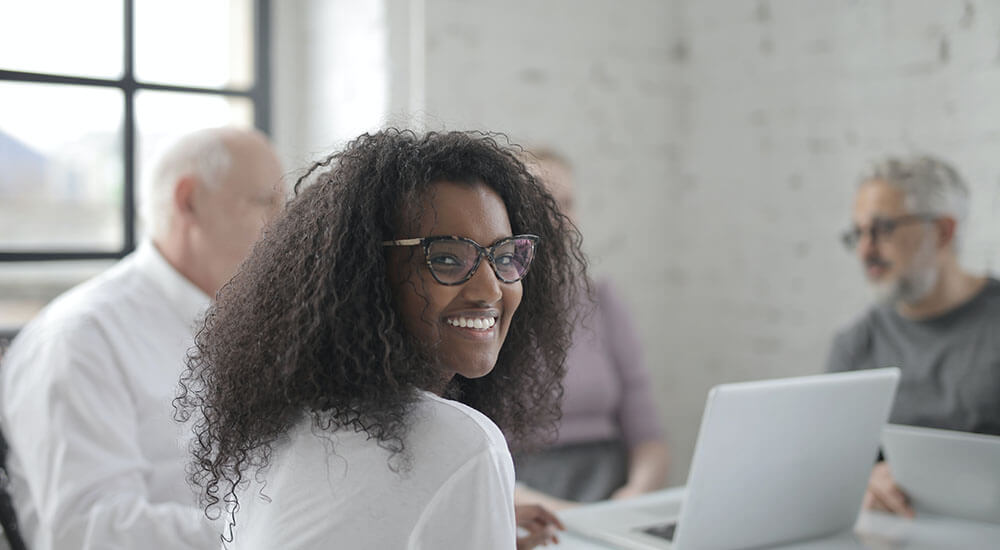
[882,424,1000,523]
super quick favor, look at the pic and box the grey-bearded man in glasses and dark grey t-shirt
[827,156,1000,515]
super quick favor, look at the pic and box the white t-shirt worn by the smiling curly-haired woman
[227,392,516,550]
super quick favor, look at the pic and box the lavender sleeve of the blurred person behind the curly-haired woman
[598,283,663,448]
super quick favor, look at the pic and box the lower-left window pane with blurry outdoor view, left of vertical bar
[0,82,125,252]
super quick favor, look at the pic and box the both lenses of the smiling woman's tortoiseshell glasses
[427,238,534,283]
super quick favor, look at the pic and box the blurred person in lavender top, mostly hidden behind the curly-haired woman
[514,150,669,509]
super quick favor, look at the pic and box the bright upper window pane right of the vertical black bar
[135,0,253,89]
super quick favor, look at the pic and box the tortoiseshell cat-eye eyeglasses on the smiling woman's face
[382,235,538,286]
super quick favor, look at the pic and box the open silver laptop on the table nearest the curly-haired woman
[564,368,899,550]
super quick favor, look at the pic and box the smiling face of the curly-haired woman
[388,181,531,386]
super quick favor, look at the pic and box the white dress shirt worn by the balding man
[0,242,220,550]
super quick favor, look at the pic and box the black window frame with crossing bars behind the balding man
[0,0,271,263]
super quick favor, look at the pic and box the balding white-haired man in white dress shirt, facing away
[0,128,284,550]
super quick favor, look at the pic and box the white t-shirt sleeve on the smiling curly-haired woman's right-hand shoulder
[407,448,517,550]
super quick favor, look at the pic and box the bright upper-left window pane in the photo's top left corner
[0,0,125,79]
